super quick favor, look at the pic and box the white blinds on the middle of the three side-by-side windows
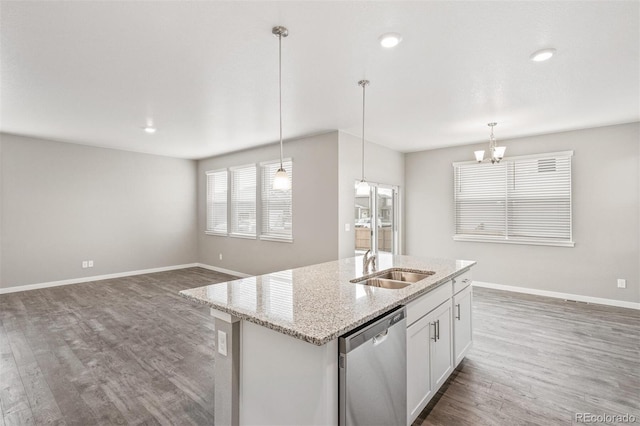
[230,164,256,237]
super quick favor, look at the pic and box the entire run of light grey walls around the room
[6,123,640,302]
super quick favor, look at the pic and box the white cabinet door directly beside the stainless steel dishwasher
[407,315,433,424]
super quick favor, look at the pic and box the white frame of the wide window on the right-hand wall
[452,151,575,247]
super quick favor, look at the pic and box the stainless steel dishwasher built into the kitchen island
[338,306,407,426]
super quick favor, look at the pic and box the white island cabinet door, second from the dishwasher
[427,302,453,390]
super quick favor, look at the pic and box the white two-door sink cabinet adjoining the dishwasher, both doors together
[407,299,453,424]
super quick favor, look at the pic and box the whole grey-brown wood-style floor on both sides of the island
[0,268,640,426]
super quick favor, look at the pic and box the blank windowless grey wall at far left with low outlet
[0,134,197,288]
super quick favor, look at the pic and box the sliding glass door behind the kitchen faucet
[355,183,398,256]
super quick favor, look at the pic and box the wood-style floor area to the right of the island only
[413,287,640,426]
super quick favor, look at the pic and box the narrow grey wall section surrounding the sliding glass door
[338,132,404,259]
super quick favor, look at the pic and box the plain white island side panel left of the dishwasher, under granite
[240,321,338,426]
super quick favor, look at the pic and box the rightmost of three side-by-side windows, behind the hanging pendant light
[260,159,293,241]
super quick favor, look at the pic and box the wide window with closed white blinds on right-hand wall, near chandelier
[453,151,574,247]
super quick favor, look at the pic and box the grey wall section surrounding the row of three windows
[198,132,338,275]
